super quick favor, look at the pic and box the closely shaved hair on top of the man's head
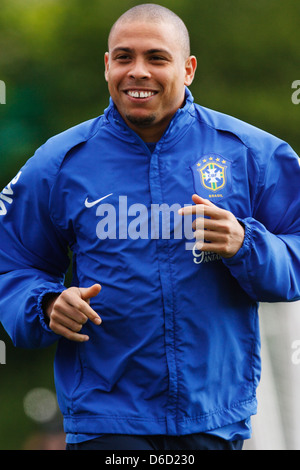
[108,3,191,58]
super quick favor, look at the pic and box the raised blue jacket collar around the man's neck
[104,87,194,148]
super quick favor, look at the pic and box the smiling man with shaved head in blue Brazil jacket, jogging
[0,4,300,450]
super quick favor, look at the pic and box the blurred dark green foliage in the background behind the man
[0,0,300,450]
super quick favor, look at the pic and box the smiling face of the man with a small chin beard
[105,21,196,142]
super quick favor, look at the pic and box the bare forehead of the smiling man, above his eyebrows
[109,21,180,53]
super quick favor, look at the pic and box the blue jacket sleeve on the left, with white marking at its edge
[0,146,69,348]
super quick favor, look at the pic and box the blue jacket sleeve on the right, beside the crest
[223,142,300,302]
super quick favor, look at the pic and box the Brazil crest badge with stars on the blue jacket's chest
[191,153,232,199]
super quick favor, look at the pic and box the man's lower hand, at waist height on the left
[45,284,102,342]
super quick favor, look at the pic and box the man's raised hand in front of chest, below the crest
[179,194,245,258]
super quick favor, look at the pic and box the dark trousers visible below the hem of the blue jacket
[66,433,244,450]
